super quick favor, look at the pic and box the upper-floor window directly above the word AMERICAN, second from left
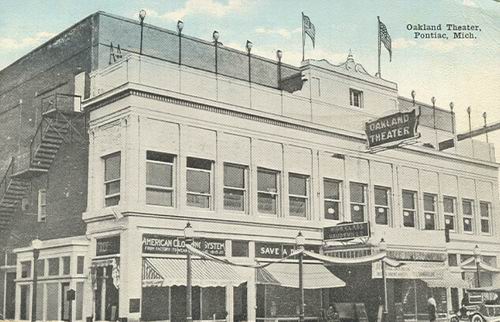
[146,151,174,207]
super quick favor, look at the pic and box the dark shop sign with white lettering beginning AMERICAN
[142,234,226,256]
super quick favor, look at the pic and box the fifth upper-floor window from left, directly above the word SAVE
[257,169,279,214]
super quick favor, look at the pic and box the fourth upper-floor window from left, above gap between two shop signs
[224,164,247,211]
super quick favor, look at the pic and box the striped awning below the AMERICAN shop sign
[142,258,247,287]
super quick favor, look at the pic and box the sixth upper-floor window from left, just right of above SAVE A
[288,173,309,217]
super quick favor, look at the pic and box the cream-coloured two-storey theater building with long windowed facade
[0,13,500,321]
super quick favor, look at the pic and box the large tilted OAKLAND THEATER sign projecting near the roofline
[365,110,419,148]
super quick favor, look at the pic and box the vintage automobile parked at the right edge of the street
[450,287,500,322]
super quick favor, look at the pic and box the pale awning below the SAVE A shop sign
[256,263,345,289]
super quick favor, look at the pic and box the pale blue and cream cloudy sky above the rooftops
[0,0,500,160]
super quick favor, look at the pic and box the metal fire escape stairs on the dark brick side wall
[0,93,87,232]
